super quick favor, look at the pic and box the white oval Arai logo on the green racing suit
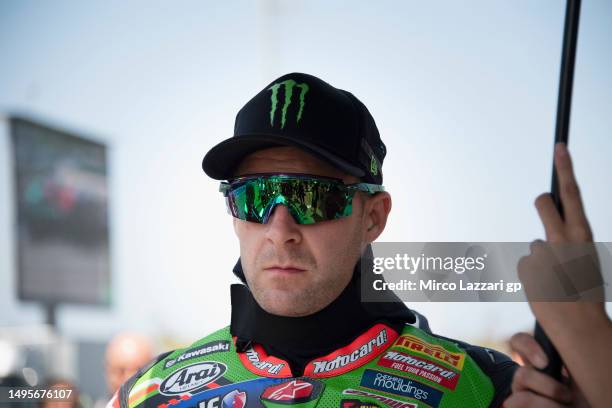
[159,361,227,395]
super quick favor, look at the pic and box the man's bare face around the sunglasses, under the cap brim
[234,147,372,317]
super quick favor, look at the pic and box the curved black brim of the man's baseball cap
[202,134,365,180]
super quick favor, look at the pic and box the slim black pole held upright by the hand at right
[534,0,580,380]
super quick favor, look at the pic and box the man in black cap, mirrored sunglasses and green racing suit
[109,73,516,408]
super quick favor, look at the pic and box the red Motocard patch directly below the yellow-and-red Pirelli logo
[377,351,459,390]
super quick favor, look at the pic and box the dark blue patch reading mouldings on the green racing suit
[359,370,443,407]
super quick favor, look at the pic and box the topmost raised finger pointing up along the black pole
[555,143,588,236]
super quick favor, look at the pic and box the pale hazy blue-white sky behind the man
[0,0,612,341]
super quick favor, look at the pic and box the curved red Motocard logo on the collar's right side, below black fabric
[304,324,395,377]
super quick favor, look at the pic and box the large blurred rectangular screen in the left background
[9,117,110,305]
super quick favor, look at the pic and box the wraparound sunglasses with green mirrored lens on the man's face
[219,173,384,224]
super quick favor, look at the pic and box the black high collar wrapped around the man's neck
[230,246,416,376]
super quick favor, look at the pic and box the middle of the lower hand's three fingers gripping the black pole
[512,367,573,404]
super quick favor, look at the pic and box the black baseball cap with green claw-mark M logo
[202,73,386,184]
